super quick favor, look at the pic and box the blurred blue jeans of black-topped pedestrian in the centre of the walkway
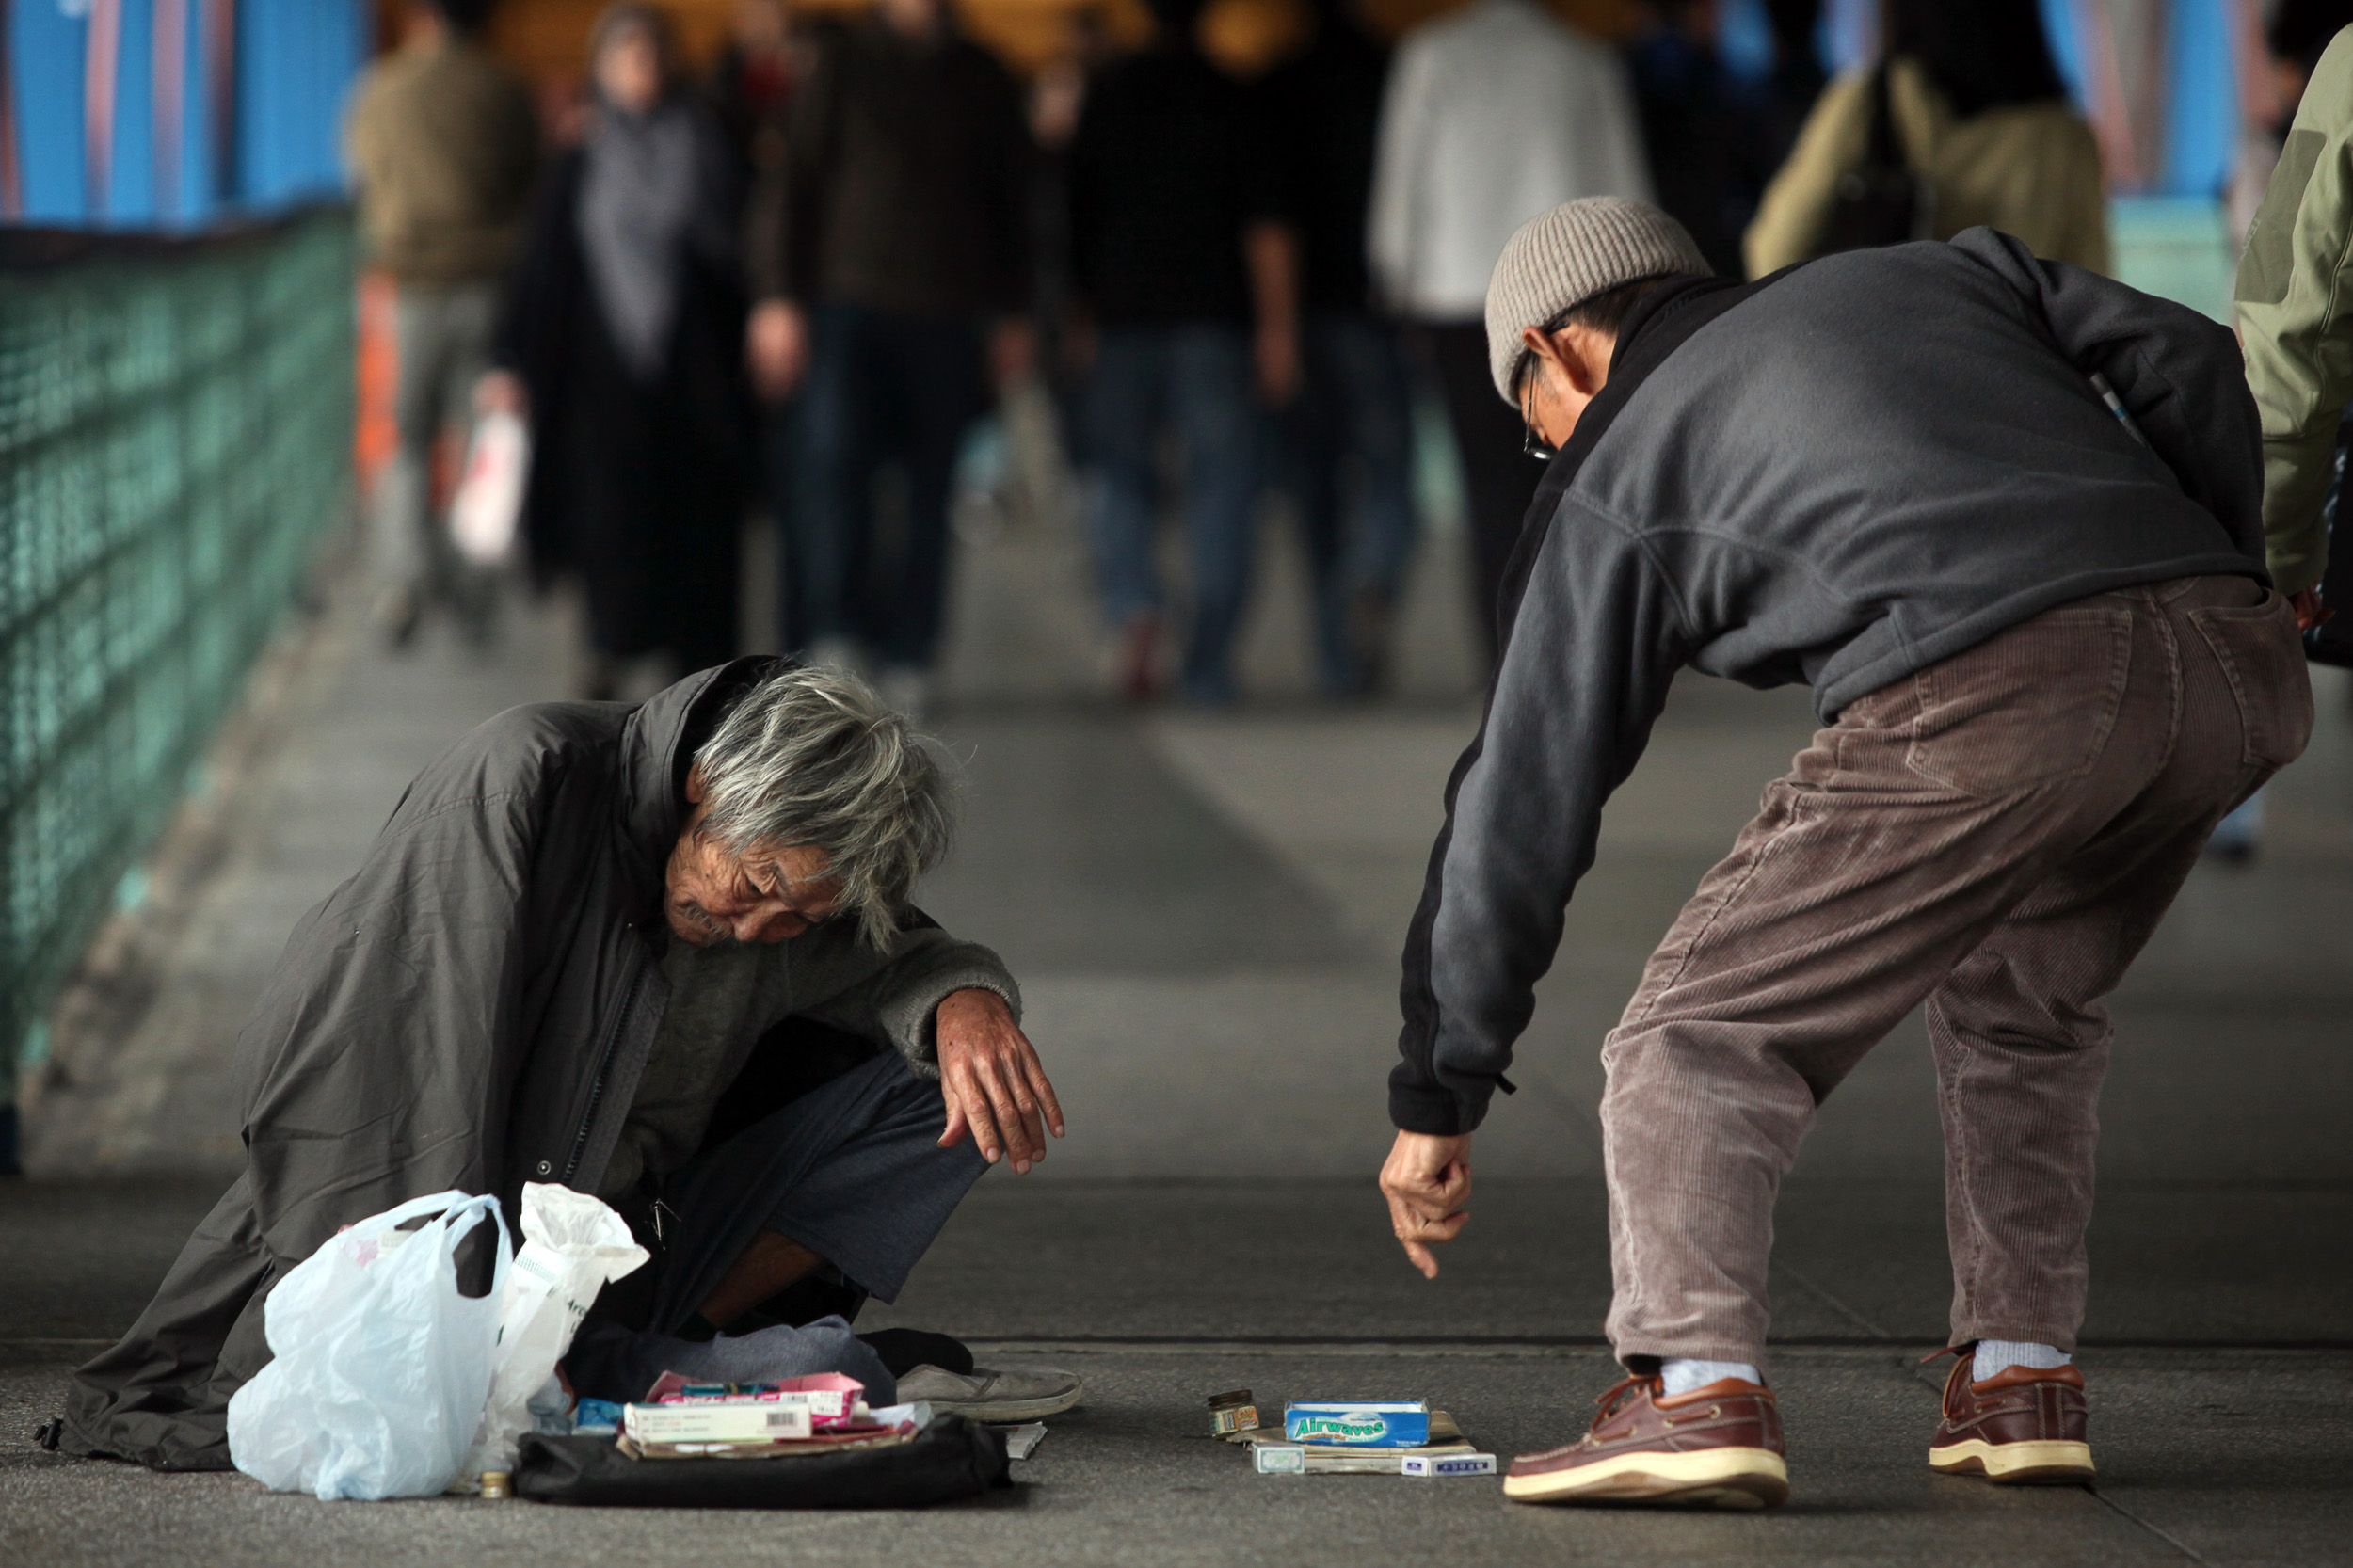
[1082,323,1264,701]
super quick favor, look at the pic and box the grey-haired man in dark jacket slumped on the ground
[61,659,1080,1469]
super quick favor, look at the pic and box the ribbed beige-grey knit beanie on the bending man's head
[1487,196,1716,403]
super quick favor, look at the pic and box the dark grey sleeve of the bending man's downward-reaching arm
[1388,505,1688,1135]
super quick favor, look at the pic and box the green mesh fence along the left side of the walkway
[0,212,353,1102]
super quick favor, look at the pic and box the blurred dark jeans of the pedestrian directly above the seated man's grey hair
[779,301,988,668]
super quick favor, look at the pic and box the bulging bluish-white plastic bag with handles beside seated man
[229,1192,513,1502]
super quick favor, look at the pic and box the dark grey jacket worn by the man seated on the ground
[61,659,1015,1469]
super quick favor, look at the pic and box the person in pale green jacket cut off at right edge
[2235,28,2353,629]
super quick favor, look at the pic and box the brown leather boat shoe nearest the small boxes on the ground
[1504,1377,1788,1509]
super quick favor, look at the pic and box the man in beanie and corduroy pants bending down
[1382,200,2311,1507]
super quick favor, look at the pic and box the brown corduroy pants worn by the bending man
[1603,577,2313,1363]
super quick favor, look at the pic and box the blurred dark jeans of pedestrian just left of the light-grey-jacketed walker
[1285,313,1417,696]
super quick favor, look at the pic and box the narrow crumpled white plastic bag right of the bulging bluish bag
[459,1182,648,1490]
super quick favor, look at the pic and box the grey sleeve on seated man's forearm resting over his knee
[793,919,1021,1079]
